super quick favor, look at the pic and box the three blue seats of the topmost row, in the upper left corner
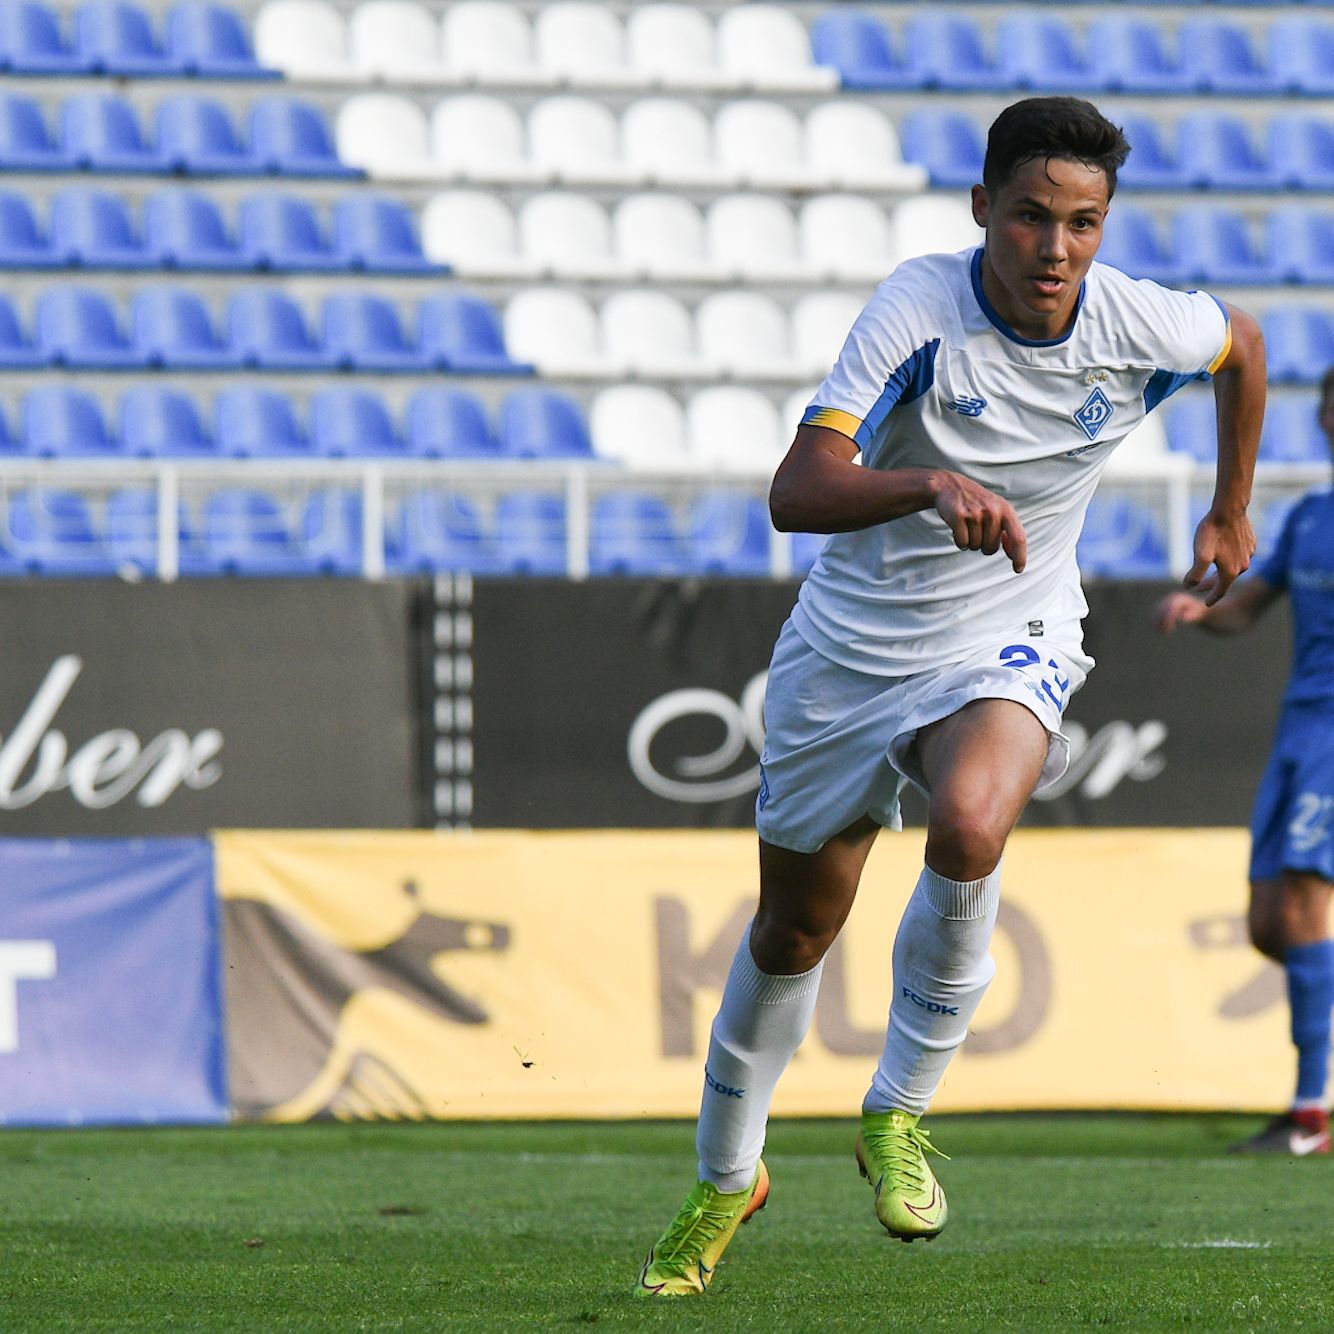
[0,0,270,79]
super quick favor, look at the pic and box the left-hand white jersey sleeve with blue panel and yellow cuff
[802,265,944,450]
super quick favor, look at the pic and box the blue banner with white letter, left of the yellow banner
[0,838,227,1126]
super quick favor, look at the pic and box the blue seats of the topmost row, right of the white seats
[810,7,1334,97]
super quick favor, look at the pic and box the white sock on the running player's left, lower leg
[695,927,824,1194]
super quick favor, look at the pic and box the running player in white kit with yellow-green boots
[636,97,1265,1295]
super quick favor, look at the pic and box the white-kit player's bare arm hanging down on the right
[1182,305,1265,607]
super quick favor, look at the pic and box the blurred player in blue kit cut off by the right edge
[1158,368,1334,1157]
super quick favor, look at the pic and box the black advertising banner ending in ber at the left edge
[0,579,423,836]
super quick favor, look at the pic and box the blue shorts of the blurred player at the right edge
[1250,704,1334,880]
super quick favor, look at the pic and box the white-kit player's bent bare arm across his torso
[768,426,1029,572]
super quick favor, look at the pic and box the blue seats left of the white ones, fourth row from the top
[0,284,532,375]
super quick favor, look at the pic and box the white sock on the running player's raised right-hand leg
[862,866,1001,1114]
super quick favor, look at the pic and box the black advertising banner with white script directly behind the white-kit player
[469,580,1289,828]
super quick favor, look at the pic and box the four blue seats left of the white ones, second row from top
[0,92,362,176]
